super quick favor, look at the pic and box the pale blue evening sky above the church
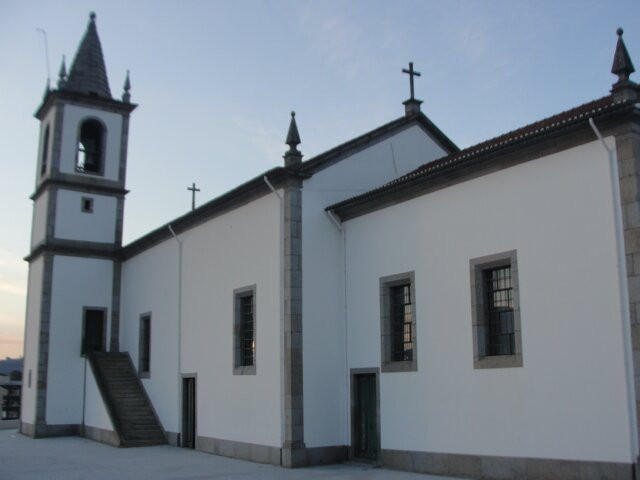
[0,0,640,357]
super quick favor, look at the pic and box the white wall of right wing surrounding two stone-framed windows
[344,142,635,463]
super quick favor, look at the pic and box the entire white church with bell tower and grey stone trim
[20,14,640,480]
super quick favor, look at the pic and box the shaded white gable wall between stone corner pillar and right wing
[302,126,444,448]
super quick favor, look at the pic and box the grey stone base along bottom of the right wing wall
[380,450,635,480]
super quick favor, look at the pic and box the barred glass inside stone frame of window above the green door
[389,284,413,362]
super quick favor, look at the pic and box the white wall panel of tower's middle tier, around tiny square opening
[55,190,118,243]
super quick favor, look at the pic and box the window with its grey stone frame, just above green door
[380,272,418,372]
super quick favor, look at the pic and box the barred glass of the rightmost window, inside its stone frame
[483,265,515,355]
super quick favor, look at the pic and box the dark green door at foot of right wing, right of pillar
[351,373,378,460]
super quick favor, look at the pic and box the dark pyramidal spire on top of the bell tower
[64,12,111,98]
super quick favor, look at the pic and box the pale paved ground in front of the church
[0,430,462,480]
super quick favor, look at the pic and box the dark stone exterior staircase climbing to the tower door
[88,352,167,447]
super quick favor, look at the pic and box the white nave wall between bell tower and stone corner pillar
[121,190,282,447]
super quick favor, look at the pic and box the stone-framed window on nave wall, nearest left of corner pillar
[233,285,256,375]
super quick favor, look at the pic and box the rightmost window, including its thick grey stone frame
[470,250,522,368]
